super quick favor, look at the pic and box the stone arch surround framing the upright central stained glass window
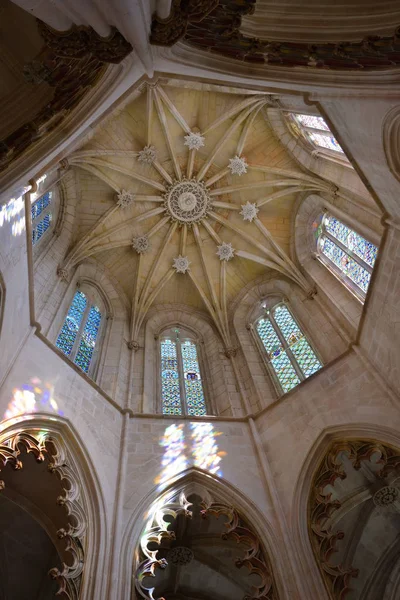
[138,304,236,414]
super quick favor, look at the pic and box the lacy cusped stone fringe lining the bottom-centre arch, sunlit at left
[135,492,278,600]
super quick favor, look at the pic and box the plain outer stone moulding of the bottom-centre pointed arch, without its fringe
[118,467,291,600]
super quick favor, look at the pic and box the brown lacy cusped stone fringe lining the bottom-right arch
[308,440,400,600]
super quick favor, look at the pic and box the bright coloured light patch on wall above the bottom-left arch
[3,377,64,419]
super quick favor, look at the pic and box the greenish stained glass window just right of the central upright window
[256,303,322,393]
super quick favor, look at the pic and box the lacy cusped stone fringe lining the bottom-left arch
[0,430,86,600]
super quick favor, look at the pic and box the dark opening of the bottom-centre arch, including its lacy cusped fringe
[135,490,278,600]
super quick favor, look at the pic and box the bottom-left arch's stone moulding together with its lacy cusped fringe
[0,413,107,600]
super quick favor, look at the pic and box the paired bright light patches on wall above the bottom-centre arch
[154,422,226,489]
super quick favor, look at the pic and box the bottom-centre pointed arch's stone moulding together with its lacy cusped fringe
[118,468,292,600]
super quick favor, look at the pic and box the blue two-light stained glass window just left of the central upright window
[56,290,103,374]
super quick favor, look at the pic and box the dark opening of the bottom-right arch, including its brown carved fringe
[308,439,400,600]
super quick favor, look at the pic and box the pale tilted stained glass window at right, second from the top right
[314,213,378,301]
